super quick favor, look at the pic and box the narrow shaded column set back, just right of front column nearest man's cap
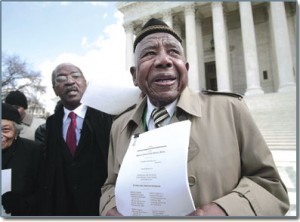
[196,15,206,89]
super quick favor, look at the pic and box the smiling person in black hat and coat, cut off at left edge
[1,103,43,216]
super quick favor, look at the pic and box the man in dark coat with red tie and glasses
[41,63,112,216]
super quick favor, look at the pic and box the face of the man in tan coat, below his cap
[130,33,189,107]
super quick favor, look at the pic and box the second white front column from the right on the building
[239,2,264,95]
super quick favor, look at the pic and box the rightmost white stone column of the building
[270,2,296,92]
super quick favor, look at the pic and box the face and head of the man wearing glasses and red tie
[53,64,87,110]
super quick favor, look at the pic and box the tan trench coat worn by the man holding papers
[100,88,289,216]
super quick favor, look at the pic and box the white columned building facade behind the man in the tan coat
[117,1,297,95]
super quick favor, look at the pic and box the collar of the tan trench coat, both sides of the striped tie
[122,87,201,131]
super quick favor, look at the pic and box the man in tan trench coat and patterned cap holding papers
[100,19,289,216]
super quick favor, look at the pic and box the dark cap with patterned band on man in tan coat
[133,18,182,52]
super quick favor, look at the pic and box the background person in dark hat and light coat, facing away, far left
[5,90,46,140]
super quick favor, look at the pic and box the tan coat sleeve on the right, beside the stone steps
[213,99,289,216]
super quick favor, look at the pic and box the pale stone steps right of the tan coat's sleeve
[244,93,297,216]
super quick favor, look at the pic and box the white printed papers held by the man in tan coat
[115,120,195,216]
